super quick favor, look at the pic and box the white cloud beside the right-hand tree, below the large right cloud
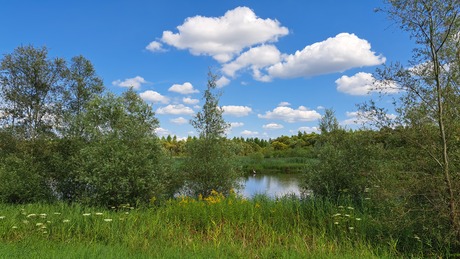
[335,72,400,95]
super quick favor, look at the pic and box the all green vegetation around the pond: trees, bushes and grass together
[0,0,460,258]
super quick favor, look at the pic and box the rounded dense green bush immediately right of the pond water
[306,130,380,200]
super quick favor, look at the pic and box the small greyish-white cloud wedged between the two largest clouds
[222,45,281,81]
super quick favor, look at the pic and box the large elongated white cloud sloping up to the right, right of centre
[260,33,385,79]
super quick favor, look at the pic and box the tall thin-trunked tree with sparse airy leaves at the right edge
[363,0,460,244]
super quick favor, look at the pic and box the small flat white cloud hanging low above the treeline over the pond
[257,106,321,123]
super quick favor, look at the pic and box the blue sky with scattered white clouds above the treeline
[0,0,414,138]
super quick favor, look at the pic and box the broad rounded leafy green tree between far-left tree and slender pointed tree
[74,89,173,205]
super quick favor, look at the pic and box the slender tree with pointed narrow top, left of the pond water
[184,72,239,196]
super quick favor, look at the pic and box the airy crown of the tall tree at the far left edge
[0,46,66,139]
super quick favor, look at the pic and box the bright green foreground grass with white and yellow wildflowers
[0,193,397,258]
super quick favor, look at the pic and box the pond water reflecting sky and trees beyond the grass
[238,173,301,198]
